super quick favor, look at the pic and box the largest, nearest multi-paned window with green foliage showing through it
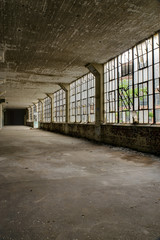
[104,34,160,124]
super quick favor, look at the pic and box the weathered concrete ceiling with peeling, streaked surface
[0,0,160,108]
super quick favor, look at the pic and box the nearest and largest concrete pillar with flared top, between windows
[86,63,104,125]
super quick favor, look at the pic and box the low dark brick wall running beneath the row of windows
[38,123,160,155]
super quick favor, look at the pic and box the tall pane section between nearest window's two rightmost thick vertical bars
[133,38,153,123]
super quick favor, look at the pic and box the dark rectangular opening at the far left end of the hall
[4,109,26,125]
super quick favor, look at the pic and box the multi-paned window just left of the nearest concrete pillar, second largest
[70,73,95,123]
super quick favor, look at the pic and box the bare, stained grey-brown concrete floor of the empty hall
[0,127,160,240]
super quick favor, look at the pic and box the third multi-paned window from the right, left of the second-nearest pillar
[53,89,66,122]
